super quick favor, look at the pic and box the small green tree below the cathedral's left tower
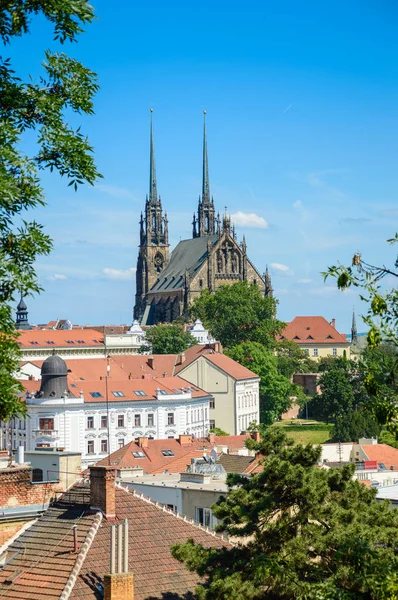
[140,323,197,354]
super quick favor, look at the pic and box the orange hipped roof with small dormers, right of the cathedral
[279,317,349,344]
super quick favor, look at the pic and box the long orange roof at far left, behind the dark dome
[17,329,104,348]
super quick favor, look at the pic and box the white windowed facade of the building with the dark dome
[20,392,209,468]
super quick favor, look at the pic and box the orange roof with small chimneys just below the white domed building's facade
[97,435,248,473]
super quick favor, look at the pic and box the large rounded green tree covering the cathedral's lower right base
[190,281,284,348]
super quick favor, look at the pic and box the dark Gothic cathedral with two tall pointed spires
[134,111,273,325]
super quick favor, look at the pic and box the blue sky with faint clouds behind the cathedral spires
[8,0,398,332]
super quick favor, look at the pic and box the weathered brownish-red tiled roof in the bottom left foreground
[0,487,228,600]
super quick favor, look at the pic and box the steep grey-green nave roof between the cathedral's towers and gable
[151,234,219,293]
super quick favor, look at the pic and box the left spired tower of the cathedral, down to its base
[134,109,169,320]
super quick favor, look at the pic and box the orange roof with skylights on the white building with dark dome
[21,376,209,403]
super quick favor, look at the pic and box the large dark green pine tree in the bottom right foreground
[172,427,398,600]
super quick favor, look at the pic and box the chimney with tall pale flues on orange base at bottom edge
[104,519,134,600]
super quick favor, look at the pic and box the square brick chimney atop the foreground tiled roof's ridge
[90,466,116,520]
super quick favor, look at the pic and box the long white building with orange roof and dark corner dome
[9,355,210,467]
